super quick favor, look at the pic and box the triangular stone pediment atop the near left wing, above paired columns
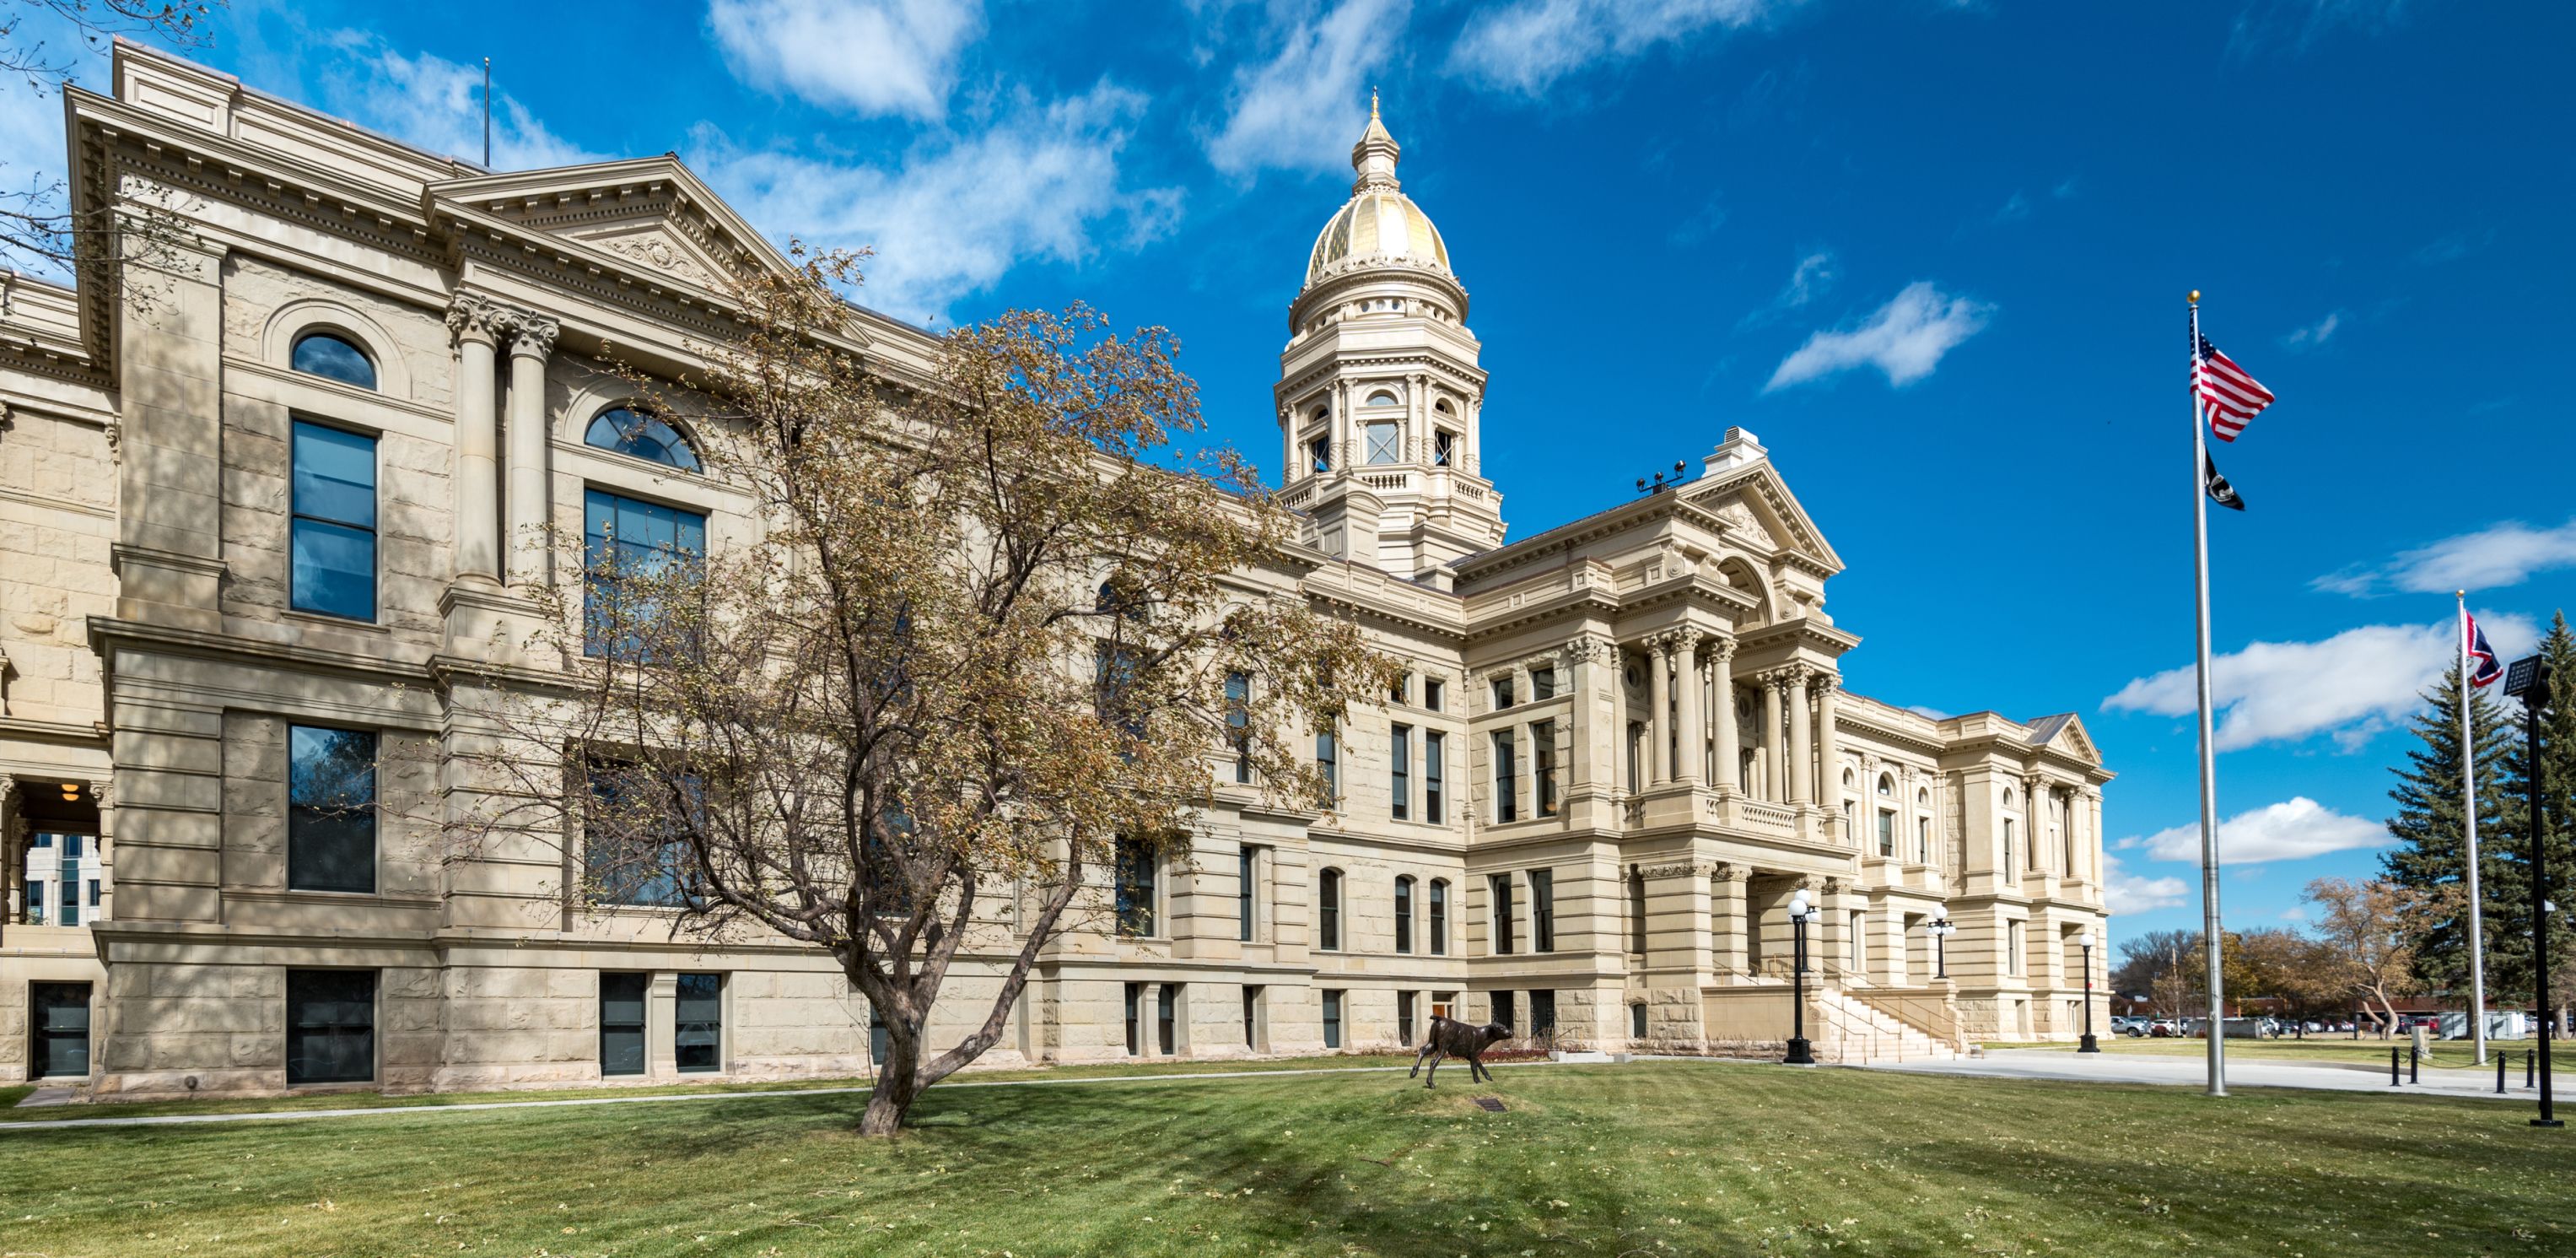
[428,154,791,291]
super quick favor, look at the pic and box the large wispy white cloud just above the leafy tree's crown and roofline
[693,80,1180,320]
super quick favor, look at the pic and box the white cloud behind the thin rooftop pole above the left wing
[317,31,603,170]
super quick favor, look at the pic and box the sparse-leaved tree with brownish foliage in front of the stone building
[463,252,1396,1134]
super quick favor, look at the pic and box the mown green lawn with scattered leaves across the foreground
[0,1062,2576,1258]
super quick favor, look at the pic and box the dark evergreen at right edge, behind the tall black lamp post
[2478,611,2576,1006]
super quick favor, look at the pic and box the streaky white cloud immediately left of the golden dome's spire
[1208,0,1412,175]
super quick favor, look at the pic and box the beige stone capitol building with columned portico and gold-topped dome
[0,44,2110,1096]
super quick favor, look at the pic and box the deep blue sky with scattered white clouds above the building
[0,0,2576,958]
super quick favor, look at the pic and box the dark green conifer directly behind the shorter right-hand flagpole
[2380,667,2530,992]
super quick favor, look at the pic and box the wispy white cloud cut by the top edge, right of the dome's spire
[1447,0,1801,95]
